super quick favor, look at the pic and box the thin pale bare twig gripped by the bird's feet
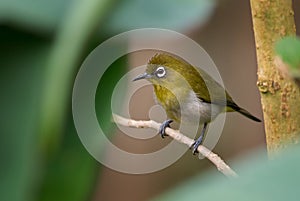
[113,114,238,177]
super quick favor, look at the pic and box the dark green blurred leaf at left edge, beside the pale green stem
[0,27,50,201]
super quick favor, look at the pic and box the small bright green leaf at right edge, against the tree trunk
[275,36,300,77]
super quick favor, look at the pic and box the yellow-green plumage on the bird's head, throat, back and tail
[146,54,260,122]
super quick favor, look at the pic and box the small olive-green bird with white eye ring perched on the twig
[133,53,261,154]
